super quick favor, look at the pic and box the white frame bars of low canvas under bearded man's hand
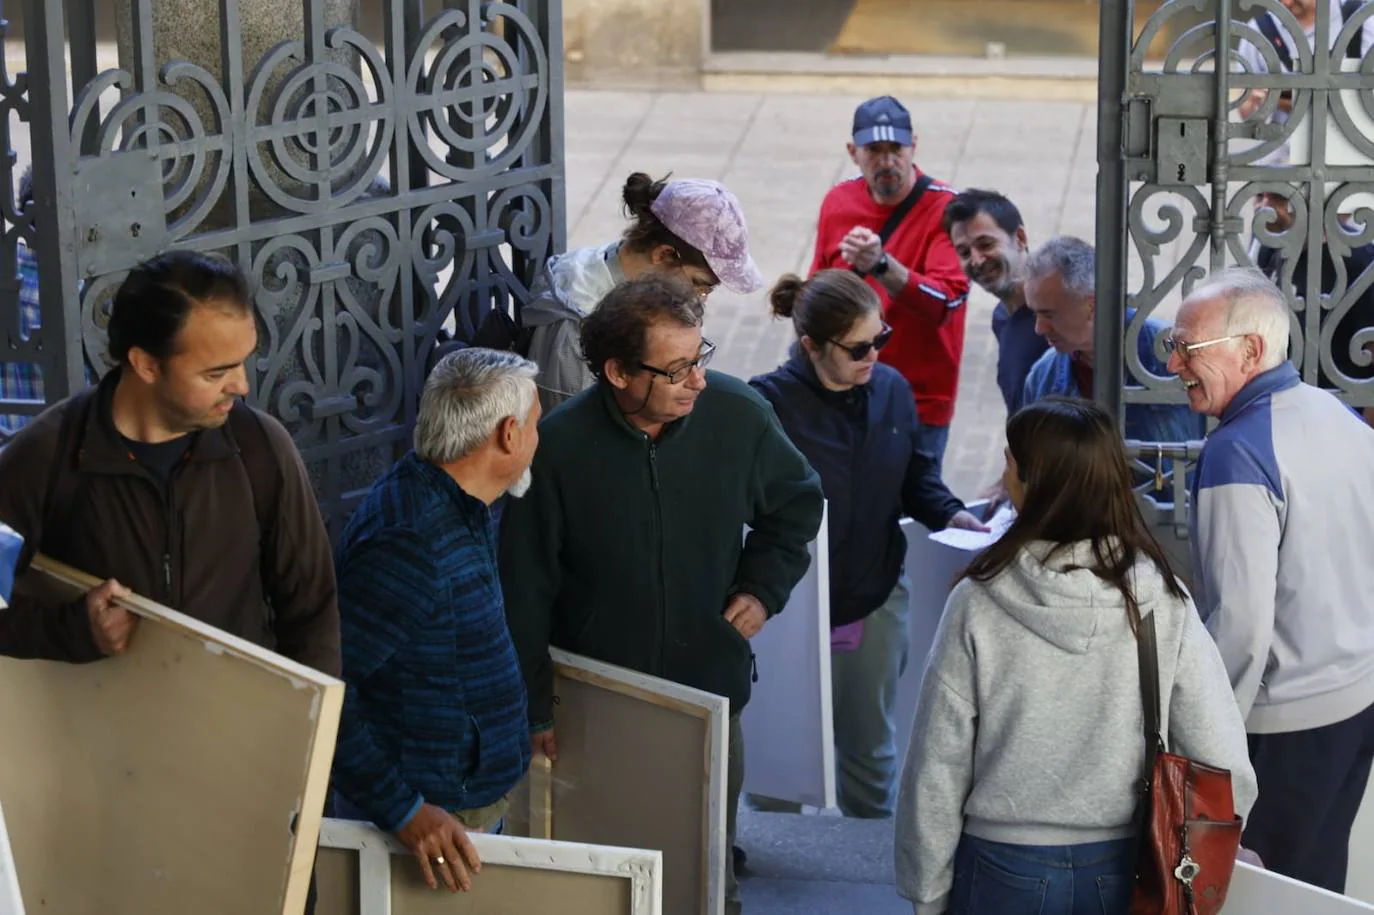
[320,819,664,915]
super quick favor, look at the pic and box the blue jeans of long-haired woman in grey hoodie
[947,835,1136,915]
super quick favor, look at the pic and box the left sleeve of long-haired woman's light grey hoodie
[896,583,978,915]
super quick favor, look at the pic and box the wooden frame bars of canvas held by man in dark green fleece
[506,648,730,915]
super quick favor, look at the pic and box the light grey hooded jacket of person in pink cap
[521,239,625,414]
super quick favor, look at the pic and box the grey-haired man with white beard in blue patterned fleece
[334,348,540,892]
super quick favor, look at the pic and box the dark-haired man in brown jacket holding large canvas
[0,245,339,676]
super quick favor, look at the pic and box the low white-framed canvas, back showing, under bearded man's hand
[320,819,664,915]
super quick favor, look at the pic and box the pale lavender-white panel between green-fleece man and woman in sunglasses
[741,508,835,806]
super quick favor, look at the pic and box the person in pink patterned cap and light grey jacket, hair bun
[519,172,764,414]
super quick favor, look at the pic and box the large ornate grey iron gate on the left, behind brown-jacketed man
[0,0,565,530]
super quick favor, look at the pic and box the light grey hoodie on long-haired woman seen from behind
[896,541,1256,915]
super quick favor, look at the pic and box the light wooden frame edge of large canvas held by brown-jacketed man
[4,554,344,915]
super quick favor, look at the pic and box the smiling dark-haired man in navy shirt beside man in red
[944,188,1050,416]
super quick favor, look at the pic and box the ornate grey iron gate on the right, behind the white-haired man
[1094,0,1374,533]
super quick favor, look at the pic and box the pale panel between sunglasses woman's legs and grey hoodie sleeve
[894,501,987,760]
